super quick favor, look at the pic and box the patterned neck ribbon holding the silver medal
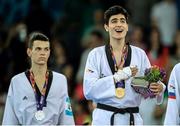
[30,71,49,110]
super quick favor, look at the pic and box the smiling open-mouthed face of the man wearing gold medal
[104,14,128,39]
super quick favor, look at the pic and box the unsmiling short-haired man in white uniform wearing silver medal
[2,32,74,125]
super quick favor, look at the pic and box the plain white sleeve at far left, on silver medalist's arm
[2,81,19,125]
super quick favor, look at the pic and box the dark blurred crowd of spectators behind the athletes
[0,0,180,125]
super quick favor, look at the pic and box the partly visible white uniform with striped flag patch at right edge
[164,63,180,125]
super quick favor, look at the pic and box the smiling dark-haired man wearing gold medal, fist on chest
[83,5,165,125]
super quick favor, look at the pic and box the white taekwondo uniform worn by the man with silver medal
[2,72,74,125]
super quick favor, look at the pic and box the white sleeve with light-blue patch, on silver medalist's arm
[59,76,75,125]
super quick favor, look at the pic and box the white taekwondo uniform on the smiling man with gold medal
[83,45,165,125]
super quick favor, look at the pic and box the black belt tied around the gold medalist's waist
[97,103,139,125]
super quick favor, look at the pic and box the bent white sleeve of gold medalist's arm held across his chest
[83,50,115,102]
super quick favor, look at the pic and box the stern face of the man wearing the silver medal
[27,40,50,65]
